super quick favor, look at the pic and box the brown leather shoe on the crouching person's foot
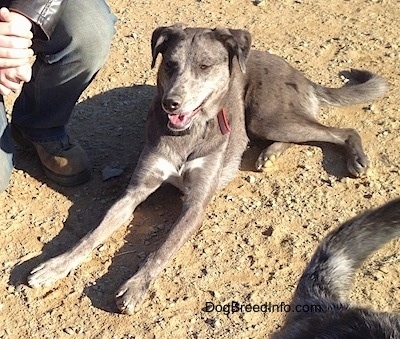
[11,125,91,186]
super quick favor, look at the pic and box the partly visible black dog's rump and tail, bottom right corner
[274,199,400,339]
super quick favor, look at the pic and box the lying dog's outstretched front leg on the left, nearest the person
[28,150,169,287]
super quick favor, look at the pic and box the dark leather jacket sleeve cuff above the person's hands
[6,0,68,40]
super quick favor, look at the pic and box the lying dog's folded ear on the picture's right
[214,28,251,73]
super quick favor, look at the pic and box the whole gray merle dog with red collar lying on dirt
[28,25,386,313]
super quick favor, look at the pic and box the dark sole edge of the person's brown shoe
[11,124,92,187]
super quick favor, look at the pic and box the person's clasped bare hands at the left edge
[0,7,33,95]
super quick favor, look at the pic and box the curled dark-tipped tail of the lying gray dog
[313,69,388,106]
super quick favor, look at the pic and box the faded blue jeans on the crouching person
[0,0,116,192]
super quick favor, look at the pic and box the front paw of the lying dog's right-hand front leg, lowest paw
[115,274,150,315]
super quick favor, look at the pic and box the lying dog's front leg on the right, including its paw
[116,153,222,314]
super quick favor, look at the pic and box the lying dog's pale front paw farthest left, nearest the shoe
[28,255,72,288]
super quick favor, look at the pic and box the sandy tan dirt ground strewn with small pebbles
[0,0,400,338]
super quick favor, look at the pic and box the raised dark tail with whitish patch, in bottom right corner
[293,198,400,304]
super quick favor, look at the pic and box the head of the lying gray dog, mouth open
[151,25,251,132]
